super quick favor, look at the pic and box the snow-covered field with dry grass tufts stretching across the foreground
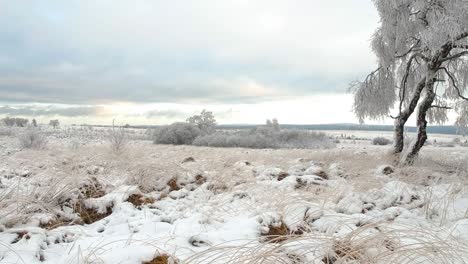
[0,127,468,264]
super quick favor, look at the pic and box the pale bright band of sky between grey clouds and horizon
[0,94,354,125]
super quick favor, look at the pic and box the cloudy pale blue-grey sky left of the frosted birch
[0,0,379,125]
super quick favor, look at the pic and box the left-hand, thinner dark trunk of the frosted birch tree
[393,78,426,154]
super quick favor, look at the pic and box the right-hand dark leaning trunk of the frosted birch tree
[404,75,436,165]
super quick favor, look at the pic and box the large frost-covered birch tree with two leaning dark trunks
[351,0,468,164]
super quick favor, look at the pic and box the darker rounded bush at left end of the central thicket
[153,122,202,145]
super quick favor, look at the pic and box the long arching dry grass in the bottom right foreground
[185,223,468,264]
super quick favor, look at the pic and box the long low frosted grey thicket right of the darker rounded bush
[193,127,335,149]
